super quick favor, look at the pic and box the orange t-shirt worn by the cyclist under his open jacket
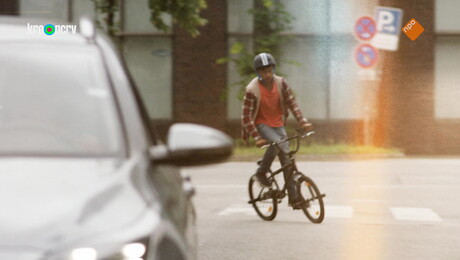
[254,82,284,127]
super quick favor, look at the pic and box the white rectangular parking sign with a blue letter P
[372,6,403,51]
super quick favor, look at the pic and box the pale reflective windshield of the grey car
[0,43,121,156]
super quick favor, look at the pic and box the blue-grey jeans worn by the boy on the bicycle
[256,124,297,200]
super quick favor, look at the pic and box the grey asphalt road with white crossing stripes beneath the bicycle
[184,158,460,260]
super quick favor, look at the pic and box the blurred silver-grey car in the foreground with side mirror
[0,18,232,260]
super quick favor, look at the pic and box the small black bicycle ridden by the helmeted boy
[248,131,326,224]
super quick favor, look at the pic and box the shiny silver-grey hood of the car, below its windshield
[0,158,151,250]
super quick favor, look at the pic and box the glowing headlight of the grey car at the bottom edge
[69,242,148,260]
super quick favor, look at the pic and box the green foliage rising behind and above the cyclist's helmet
[221,0,294,99]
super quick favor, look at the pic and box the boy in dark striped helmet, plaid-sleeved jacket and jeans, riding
[241,53,312,207]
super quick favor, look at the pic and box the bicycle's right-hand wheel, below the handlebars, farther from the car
[297,173,324,224]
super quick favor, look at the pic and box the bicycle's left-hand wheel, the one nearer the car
[249,175,278,220]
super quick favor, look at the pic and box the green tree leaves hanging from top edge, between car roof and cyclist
[92,0,207,37]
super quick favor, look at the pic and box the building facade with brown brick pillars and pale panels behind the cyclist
[0,0,460,154]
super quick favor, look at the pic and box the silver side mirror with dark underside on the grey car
[149,123,233,166]
